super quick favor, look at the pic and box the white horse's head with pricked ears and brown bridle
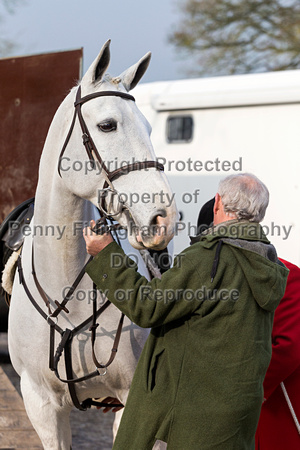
[59,41,177,249]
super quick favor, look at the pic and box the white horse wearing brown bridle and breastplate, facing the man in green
[8,41,177,450]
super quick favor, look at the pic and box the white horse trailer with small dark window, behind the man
[133,70,300,265]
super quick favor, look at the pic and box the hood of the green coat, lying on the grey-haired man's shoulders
[191,220,289,311]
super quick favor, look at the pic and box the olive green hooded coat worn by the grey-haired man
[87,221,288,450]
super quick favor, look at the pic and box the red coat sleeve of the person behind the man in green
[264,260,300,399]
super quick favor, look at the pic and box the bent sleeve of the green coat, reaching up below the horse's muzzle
[86,242,205,328]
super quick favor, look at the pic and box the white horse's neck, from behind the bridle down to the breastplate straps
[32,88,94,292]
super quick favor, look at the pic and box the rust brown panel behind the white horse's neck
[0,49,82,222]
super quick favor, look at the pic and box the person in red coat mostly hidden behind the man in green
[197,198,300,450]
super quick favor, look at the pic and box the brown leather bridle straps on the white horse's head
[58,86,164,216]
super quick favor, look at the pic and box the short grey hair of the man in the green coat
[218,173,269,222]
